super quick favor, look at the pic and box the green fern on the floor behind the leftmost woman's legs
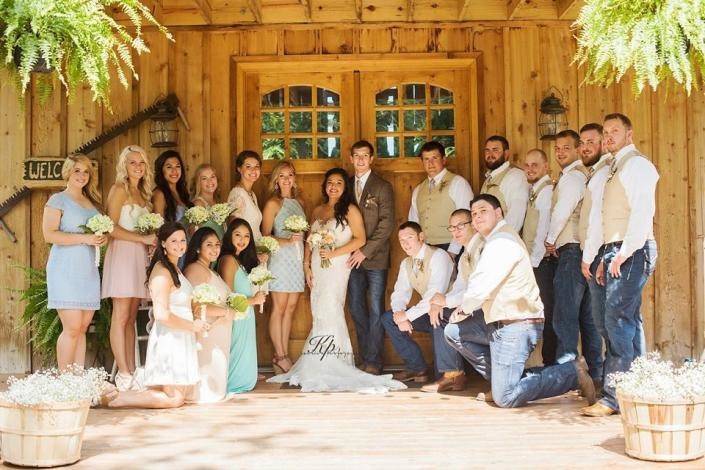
[18,266,112,363]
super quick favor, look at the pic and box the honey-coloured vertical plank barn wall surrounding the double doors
[0,22,705,373]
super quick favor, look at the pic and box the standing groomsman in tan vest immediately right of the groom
[409,140,473,258]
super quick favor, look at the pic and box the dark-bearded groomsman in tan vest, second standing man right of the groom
[480,135,529,232]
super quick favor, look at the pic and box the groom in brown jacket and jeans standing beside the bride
[348,140,394,375]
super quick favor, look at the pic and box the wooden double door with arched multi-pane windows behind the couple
[234,54,479,365]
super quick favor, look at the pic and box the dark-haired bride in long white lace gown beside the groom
[268,168,406,393]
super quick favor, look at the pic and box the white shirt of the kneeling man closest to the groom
[391,244,453,321]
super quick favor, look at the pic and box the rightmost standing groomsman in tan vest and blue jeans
[581,113,659,416]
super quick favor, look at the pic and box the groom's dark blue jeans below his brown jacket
[348,268,387,368]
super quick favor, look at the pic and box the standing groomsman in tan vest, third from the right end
[546,130,603,381]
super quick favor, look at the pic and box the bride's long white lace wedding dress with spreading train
[268,219,406,393]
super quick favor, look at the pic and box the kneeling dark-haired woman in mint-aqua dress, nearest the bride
[218,219,266,393]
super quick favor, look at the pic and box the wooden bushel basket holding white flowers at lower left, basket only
[0,401,90,467]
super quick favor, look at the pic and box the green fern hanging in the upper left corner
[0,0,172,107]
